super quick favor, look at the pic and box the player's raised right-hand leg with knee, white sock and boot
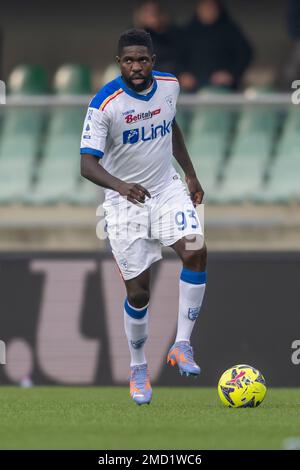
[167,235,207,376]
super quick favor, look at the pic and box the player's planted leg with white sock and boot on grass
[124,268,152,405]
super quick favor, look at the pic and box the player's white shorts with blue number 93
[103,176,204,280]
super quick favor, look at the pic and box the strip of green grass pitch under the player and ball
[0,387,300,450]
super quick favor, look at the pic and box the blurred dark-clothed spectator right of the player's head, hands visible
[179,0,252,91]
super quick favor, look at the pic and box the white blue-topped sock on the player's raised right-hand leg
[175,268,206,342]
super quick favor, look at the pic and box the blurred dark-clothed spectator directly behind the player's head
[133,0,180,75]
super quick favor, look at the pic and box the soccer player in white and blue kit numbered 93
[80,29,206,405]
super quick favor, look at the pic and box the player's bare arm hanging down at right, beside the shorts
[172,120,204,205]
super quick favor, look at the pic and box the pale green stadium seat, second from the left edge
[27,65,90,204]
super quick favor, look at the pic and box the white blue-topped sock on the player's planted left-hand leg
[124,299,149,366]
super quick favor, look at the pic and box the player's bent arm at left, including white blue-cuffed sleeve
[80,107,151,204]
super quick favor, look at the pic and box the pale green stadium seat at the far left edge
[0,65,46,204]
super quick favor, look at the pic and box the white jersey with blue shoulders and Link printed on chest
[80,71,179,200]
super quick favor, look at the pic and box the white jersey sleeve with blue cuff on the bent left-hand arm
[80,107,110,158]
